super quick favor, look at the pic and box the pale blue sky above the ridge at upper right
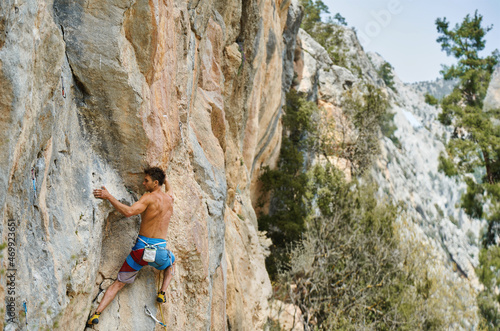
[323,0,500,83]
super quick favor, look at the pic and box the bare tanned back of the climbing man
[139,190,174,240]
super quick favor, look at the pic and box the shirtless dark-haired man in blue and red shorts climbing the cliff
[87,167,175,325]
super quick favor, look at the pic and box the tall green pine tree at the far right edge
[436,11,500,330]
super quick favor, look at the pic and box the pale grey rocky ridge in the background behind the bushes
[296,29,488,329]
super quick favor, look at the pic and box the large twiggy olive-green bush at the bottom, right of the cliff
[275,164,452,330]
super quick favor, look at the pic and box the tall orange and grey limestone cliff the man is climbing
[0,0,301,330]
